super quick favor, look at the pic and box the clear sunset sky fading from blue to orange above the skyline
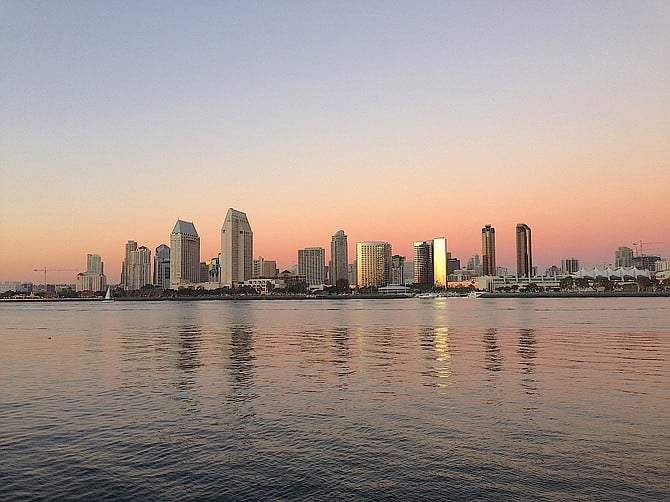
[0,0,670,283]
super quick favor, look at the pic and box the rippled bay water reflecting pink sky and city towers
[0,298,670,500]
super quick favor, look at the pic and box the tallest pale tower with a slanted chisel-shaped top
[221,207,254,286]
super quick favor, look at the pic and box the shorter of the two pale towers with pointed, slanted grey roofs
[170,220,200,289]
